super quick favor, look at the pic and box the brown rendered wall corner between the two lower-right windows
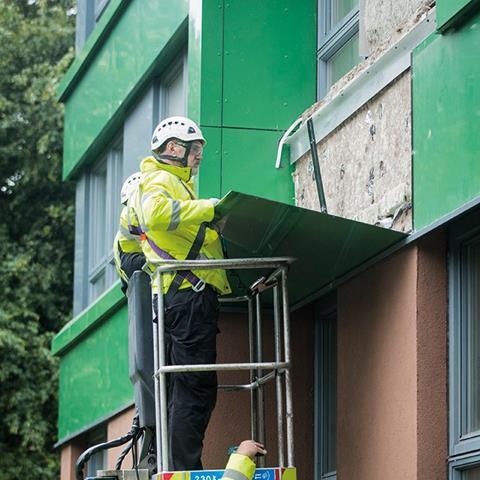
[337,235,447,480]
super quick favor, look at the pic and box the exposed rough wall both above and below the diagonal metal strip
[293,0,434,232]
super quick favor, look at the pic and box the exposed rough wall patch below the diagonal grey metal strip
[293,73,412,232]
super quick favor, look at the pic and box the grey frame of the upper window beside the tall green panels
[317,0,360,100]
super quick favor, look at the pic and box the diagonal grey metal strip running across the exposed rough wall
[285,9,436,163]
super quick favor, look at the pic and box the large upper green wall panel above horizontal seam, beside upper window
[223,0,317,129]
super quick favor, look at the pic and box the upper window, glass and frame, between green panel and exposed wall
[317,0,361,98]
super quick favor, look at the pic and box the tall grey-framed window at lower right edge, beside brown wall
[449,214,480,480]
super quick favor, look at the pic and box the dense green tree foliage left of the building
[0,0,74,480]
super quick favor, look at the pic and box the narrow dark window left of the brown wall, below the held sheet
[315,303,337,480]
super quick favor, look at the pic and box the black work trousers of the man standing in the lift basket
[161,286,219,471]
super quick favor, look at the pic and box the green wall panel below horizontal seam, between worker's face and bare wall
[221,128,294,204]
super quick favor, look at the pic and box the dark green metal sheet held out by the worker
[217,192,406,305]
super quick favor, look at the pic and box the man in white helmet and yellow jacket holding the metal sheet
[129,117,231,471]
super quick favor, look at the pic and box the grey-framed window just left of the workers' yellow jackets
[86,143,122,304]
